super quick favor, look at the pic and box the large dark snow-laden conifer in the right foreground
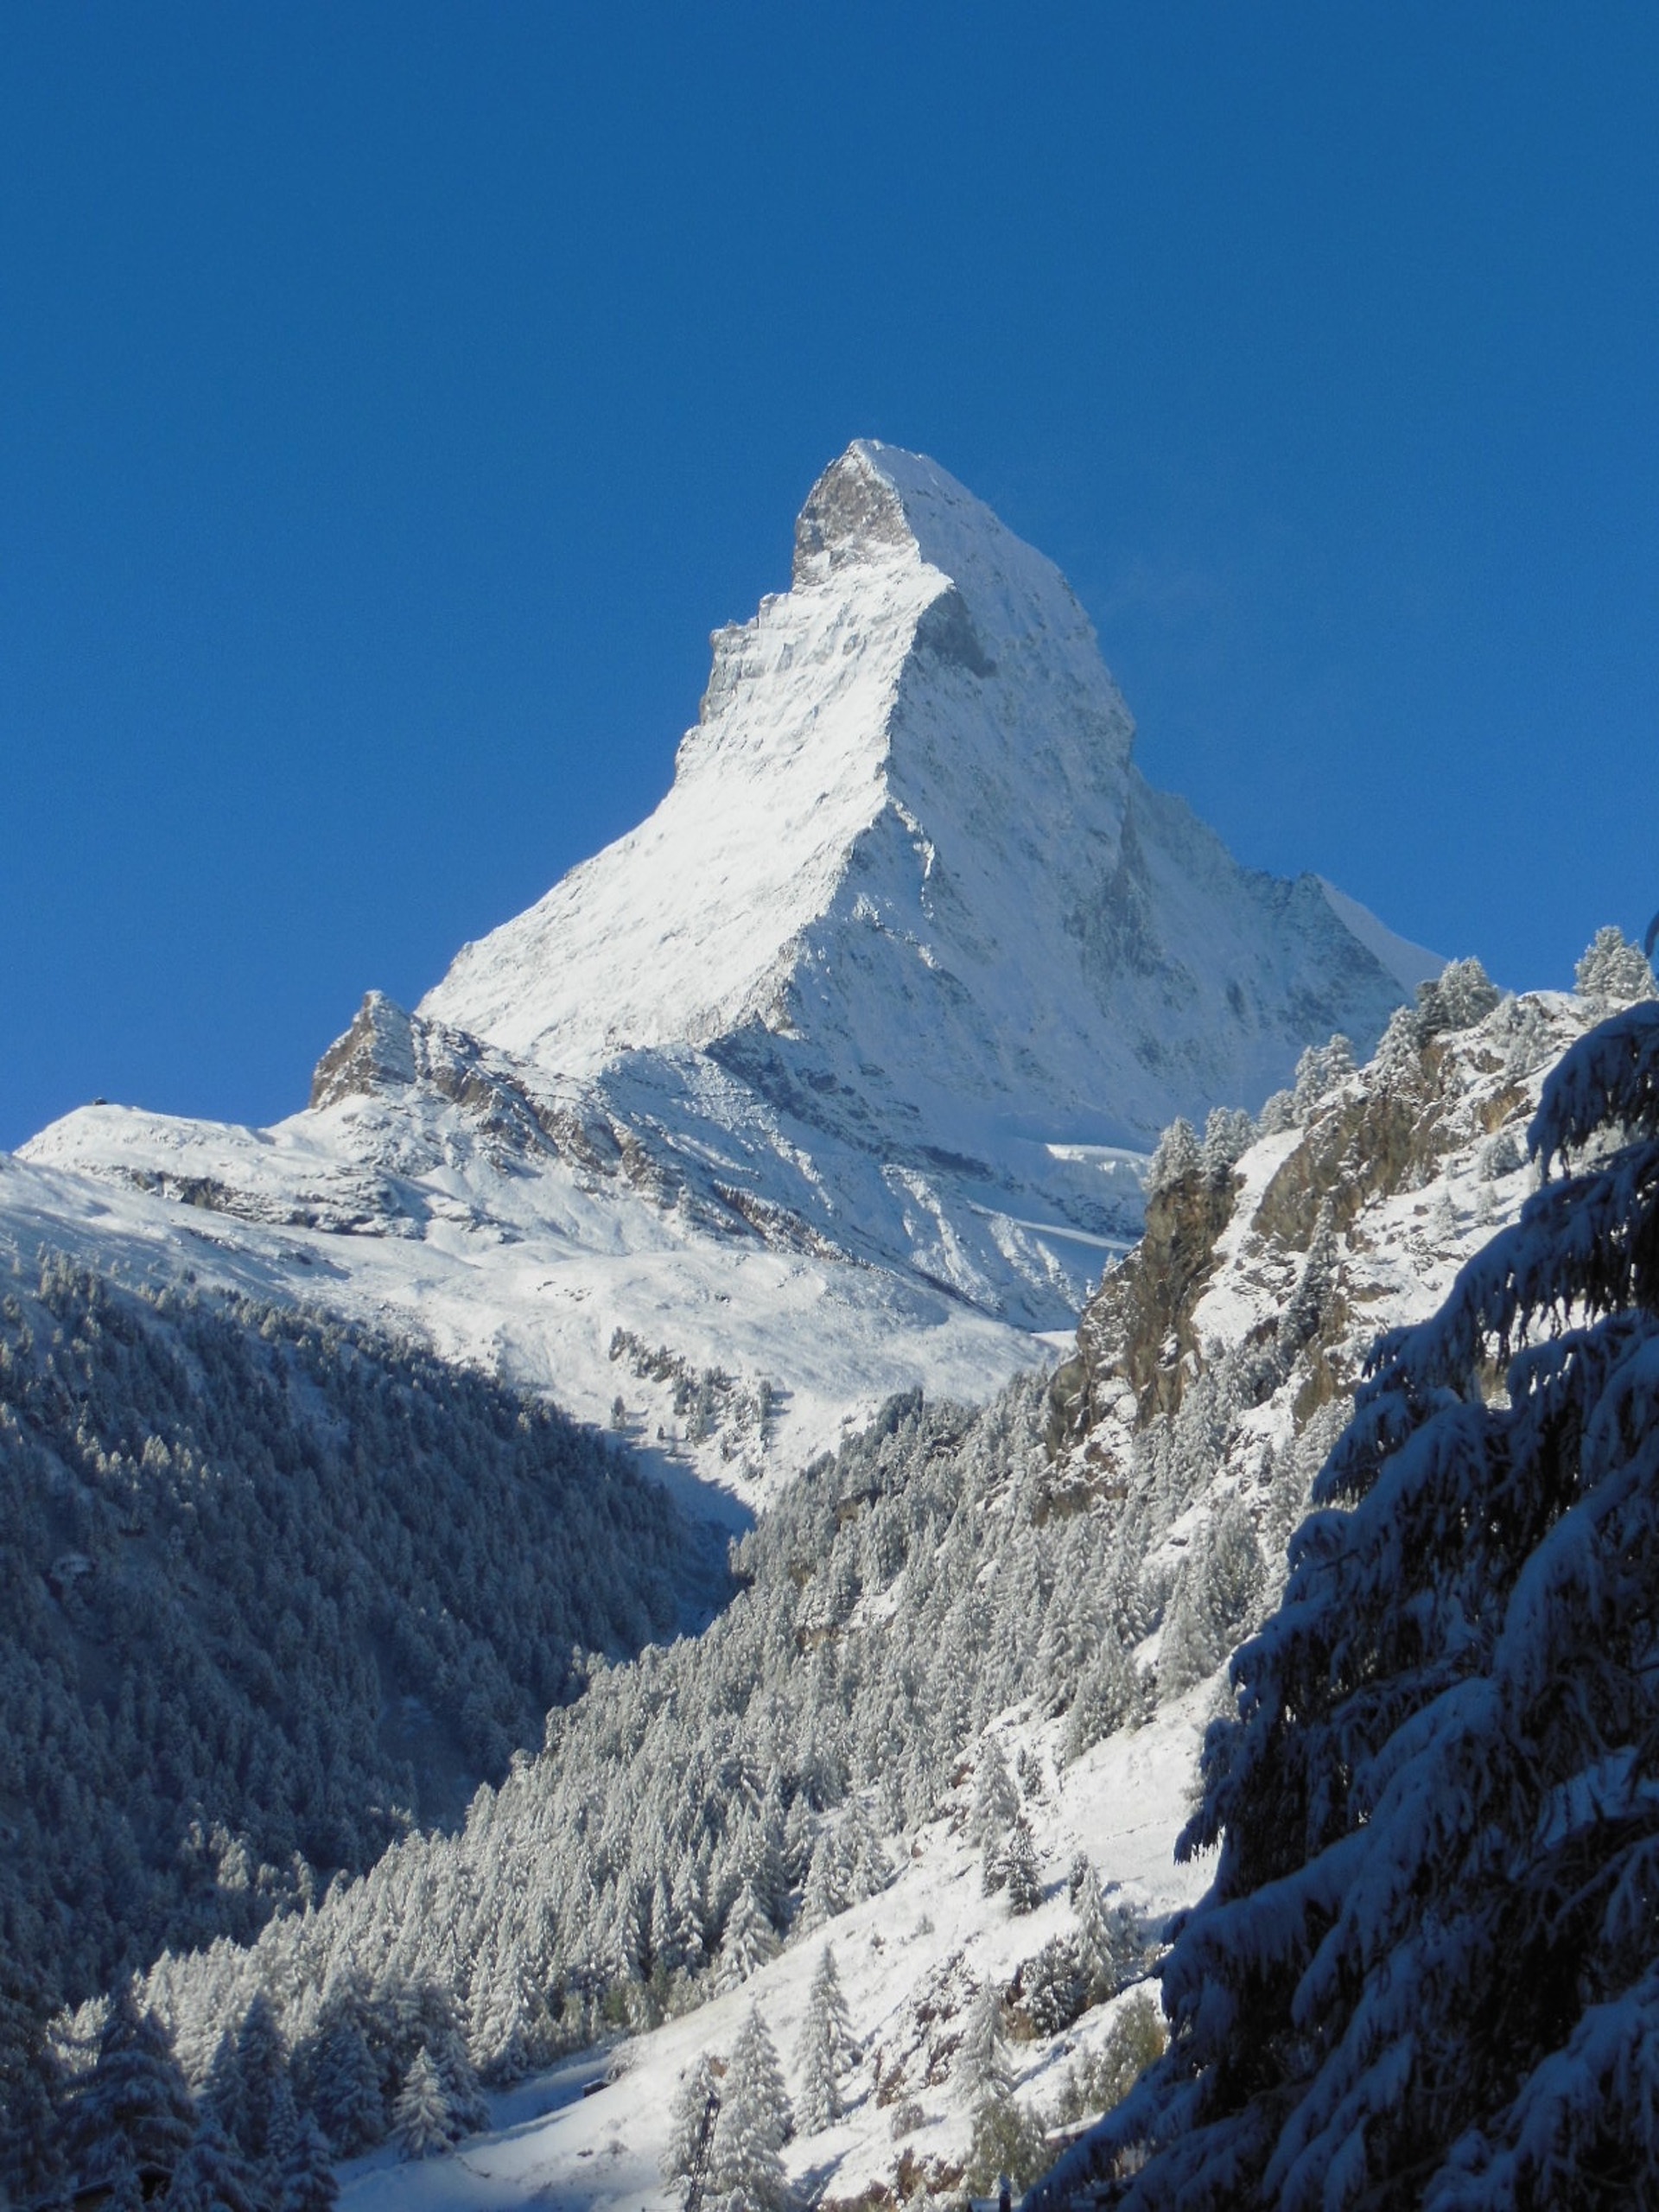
[1038,1002,1659,2212]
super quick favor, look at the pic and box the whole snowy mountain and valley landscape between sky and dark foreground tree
[0,440,1652,2212]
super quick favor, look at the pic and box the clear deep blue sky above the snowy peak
[0,0,1659,1146]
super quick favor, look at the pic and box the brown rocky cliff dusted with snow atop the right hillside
[1048,963,1599,1573]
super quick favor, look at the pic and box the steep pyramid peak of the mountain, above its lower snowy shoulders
[420,440,1438,1159]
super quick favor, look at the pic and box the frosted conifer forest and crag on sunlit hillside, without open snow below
[10,947,1650,2202]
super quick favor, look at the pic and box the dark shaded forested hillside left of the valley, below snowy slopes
[0,1263,703,1998]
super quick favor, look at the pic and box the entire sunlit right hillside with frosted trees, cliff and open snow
[81,963,1646,2208]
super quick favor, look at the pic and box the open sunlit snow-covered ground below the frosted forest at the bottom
[340,1683,1214,2212]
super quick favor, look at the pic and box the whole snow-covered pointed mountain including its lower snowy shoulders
[13,440,1438,1484]
